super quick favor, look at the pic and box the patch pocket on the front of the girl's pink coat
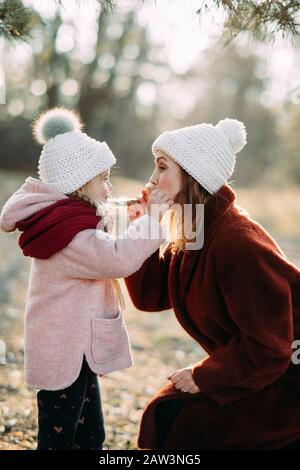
[92,310,129,364]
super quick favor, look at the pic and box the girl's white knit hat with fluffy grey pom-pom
[33,108,116,194]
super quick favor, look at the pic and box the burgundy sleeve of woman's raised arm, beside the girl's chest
[125,245,172,312]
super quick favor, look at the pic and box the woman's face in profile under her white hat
[149,150,181,196]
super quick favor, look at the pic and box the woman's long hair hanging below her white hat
[169,167,212,254]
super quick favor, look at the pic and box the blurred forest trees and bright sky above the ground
[0,0,300,186]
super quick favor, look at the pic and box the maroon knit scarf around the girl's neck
[16,197,101,259]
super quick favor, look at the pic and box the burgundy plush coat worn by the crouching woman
[125,185,300,449]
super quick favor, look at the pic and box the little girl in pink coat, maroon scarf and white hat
[0,108,172,450]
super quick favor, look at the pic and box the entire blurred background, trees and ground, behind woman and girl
[0,0,300,449]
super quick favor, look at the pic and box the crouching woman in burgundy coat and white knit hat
[126,119,300,449]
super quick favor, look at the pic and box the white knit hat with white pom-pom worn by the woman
[152,118,247,194]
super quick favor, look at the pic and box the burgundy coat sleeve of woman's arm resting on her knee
[192,237,293,406]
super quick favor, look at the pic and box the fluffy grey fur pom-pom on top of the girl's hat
[32,107,83,145]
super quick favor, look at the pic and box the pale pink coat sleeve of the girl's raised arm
[54,215,166,279]
